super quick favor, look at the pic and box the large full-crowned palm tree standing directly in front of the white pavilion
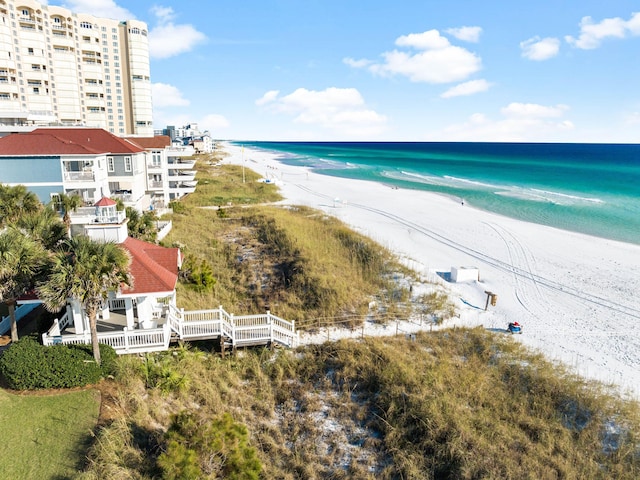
[38,236,133,364]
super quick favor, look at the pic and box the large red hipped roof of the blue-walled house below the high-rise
[0,128,144,155]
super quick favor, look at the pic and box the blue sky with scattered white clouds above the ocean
[49,0,640,143]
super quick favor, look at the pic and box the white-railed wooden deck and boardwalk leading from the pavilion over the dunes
[42,305,299,354]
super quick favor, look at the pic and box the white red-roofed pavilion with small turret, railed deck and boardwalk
[42,197,298,354]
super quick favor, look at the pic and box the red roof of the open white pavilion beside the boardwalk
[122,237,181,294]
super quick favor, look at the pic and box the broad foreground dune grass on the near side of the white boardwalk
[76,328,640,479]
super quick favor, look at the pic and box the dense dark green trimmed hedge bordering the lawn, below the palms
[0,337,116,390]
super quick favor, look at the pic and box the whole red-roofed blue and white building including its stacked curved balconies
[0,128,196,211]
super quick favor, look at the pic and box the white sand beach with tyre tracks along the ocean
[223,144,640,398]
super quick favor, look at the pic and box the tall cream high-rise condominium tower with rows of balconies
[0,0,153,136]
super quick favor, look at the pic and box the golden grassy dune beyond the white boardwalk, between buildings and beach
[163,160,424,328]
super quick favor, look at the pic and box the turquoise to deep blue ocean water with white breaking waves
[242,142,640,244]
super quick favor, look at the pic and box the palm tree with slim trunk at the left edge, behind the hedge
[0,228,47,342]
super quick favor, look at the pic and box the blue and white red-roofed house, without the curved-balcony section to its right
[0,128,149,211]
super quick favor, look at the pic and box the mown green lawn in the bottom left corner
[0,389,100,479]
